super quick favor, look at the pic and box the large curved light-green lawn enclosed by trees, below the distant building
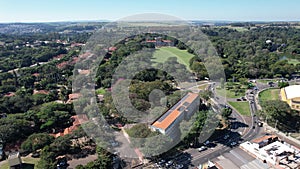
[152,47,194,70]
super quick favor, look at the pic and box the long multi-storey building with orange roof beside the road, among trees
[150,93,200,138]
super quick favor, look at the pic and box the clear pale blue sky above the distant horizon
[0,0,300,22]
